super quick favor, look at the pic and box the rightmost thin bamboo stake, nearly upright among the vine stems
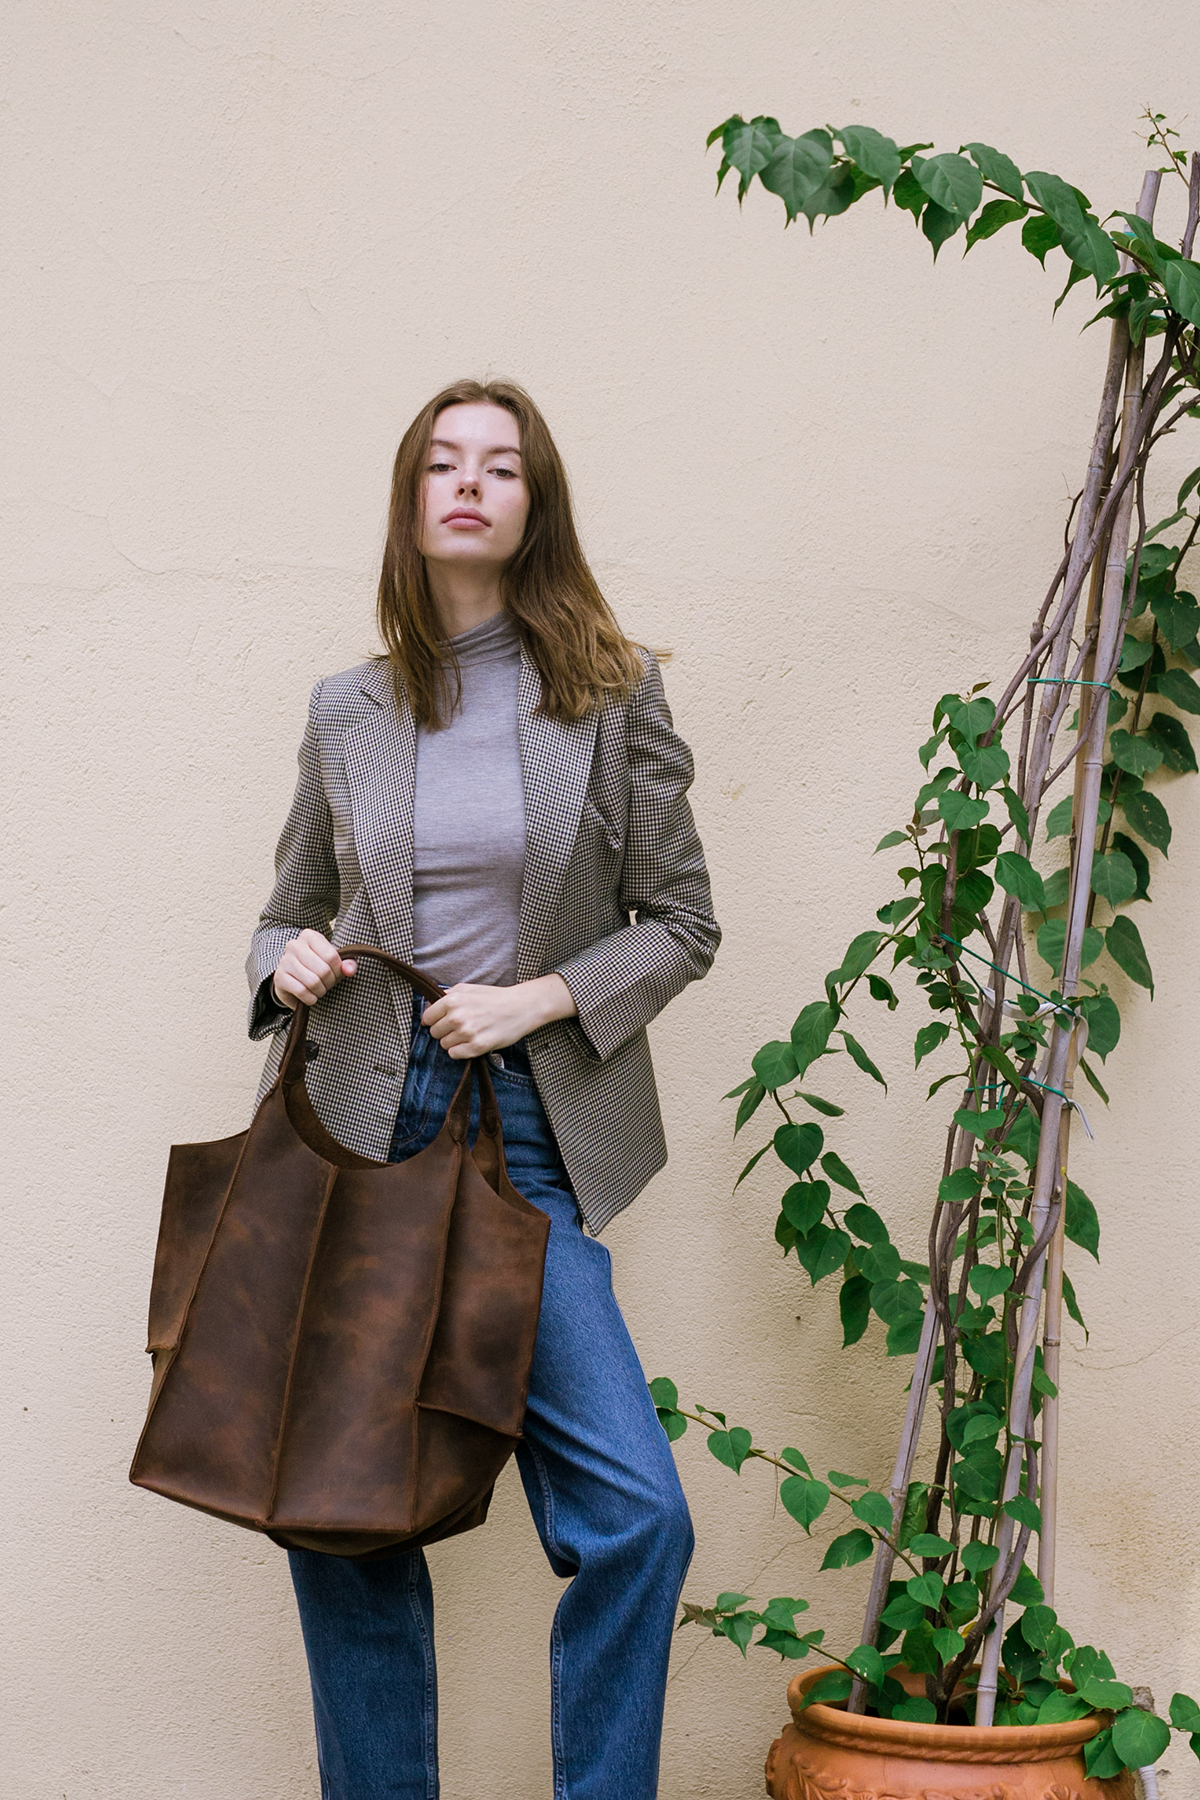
[1038,169,1162,1606]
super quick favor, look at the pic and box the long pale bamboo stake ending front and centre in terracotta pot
[975,175,1159,1724]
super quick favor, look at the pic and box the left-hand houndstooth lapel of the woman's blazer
[345,662,417,1039]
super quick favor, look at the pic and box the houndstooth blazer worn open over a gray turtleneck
[246,652,720,1231]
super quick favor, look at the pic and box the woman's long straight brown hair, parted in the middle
[376,382,644,727]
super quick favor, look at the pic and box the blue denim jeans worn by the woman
[290,1003,693,1800]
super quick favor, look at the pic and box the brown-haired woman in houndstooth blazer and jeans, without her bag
[246,382,720,1800]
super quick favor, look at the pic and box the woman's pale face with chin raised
[421,401,529,571]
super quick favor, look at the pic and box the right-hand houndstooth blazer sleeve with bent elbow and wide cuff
[554,659,721,1060]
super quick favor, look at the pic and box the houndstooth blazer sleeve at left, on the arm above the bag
[246,682,340,1039]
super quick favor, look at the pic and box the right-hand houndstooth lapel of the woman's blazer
[521,652,599,981]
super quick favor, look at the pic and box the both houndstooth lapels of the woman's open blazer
[345,650,599,1000]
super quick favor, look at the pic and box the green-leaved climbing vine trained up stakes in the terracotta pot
[651,113,1200,1778]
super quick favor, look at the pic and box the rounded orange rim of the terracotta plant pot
[788,1663,1103,1762]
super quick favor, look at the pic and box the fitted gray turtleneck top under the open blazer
[412,612,525,986]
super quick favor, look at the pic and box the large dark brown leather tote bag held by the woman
[130,945,551,1557]
